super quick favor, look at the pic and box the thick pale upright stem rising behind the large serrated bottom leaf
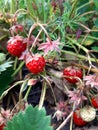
[39,81,46,109]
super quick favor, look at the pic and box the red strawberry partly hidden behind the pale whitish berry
[73,109,87,126]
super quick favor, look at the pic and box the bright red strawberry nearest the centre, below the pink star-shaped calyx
[26,55,46,74]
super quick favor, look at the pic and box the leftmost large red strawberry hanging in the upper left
[7,36,26,57]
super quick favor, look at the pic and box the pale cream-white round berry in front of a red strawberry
[80,106,96,122]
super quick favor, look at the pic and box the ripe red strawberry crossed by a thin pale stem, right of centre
[63,66,82,83]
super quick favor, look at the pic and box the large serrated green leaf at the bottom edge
[4,105,52,130]
